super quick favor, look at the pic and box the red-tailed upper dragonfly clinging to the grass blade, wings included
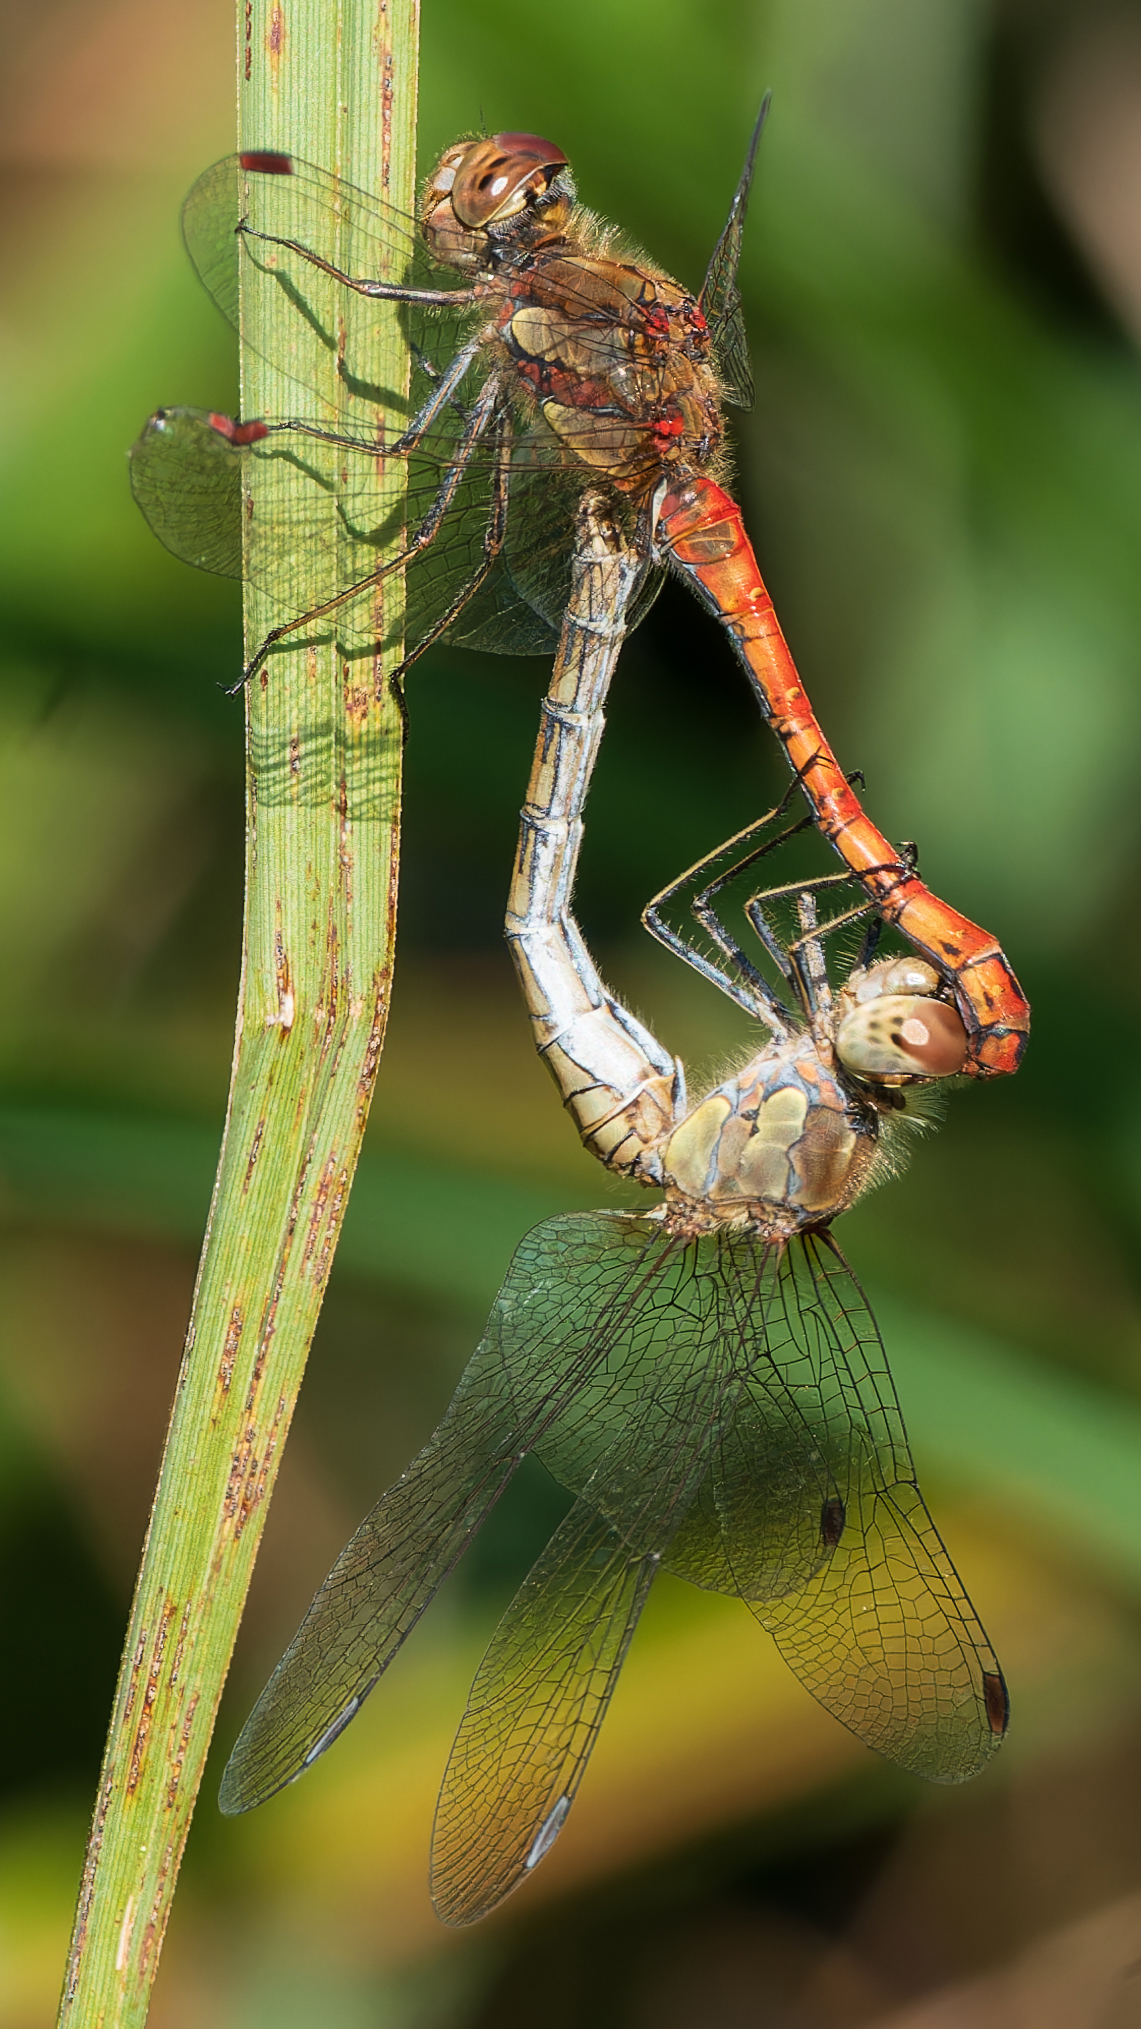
[132,101,1029,1077]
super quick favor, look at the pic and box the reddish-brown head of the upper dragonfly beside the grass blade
[420,134,575,274]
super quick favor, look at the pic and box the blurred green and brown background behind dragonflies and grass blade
[0,0,1141,2029]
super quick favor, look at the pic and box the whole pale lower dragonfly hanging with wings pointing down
[221,495,1007,1923]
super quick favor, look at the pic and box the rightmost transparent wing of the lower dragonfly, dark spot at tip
[747,1234,1007,1781]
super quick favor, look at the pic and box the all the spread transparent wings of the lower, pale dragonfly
[223,1213,1005,1923]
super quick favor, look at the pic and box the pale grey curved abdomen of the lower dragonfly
[504,493,686,1183]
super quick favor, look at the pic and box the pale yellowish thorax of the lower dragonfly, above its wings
[662,1033,879,1240]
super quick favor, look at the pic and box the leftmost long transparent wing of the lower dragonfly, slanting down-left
[221,1213,676,1812]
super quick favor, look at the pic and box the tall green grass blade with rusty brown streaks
[59,0,418,2029]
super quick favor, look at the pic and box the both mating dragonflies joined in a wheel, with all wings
[132,116,1027,1923]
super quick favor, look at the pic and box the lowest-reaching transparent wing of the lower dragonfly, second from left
[432,1290,731,1923]
